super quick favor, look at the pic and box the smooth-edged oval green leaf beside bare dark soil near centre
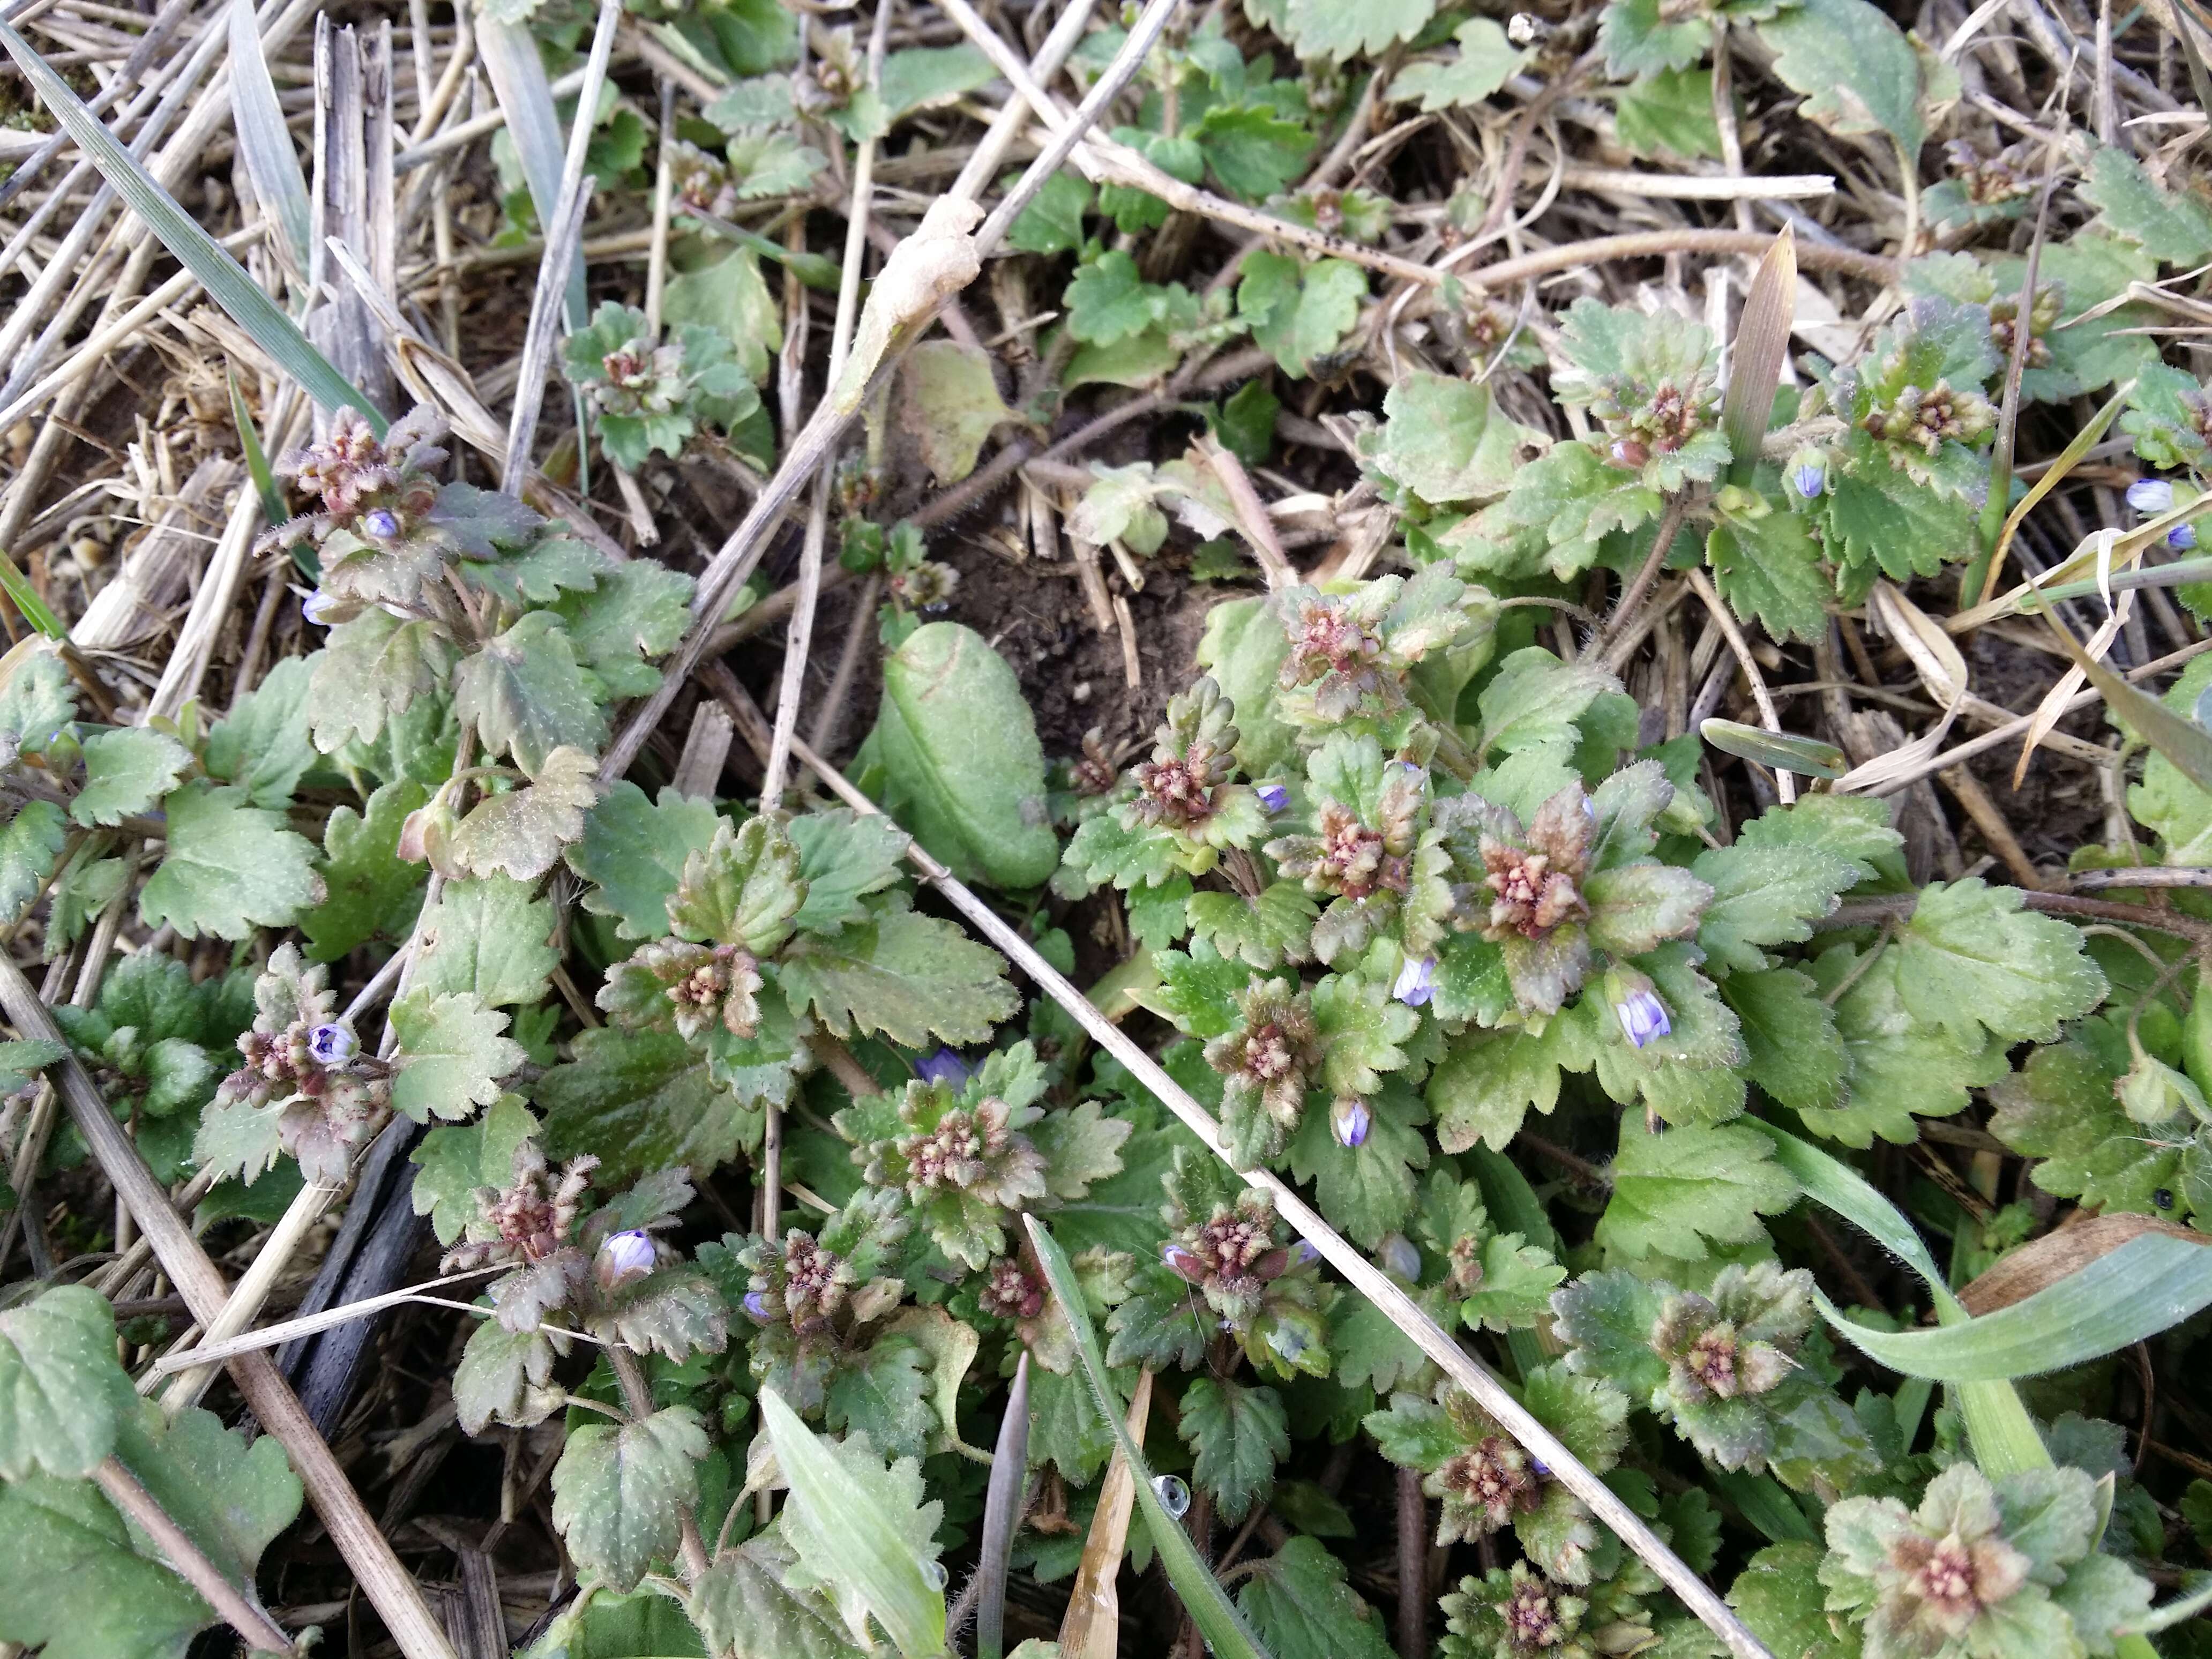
[861,622,1059,887]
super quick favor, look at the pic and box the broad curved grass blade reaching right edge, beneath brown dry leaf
[1822,1232,2212,1382]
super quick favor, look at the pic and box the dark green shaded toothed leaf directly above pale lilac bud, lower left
[531,1026,761,1186]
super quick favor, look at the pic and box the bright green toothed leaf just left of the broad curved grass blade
[1597,1117,1798,1261]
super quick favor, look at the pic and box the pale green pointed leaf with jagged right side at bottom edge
[761,1389,945,1659]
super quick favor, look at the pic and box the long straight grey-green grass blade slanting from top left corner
[0,22,385,438]
